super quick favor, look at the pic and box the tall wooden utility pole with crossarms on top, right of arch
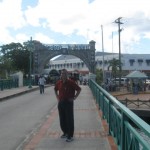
[115,17,123,86]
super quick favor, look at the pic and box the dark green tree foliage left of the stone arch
[0,43,30,78]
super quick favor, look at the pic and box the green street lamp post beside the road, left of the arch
[29,37,32,88]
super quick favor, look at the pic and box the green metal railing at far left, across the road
[0,79,18,91]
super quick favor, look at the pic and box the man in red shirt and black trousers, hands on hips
[54,69,81,142]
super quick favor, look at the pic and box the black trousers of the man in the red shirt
[58,100,74,137]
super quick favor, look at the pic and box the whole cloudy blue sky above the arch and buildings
[0,0,150,54]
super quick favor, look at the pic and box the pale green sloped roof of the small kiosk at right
[126,71,148,79]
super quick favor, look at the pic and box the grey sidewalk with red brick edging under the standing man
[23,86,117,150]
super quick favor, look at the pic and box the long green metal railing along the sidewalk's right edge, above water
[89,80,150,150]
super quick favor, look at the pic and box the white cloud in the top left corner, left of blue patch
[0,0,26,44]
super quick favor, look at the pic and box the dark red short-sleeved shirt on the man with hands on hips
[54,79,81,100]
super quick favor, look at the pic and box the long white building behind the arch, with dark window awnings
[49,52,150,77]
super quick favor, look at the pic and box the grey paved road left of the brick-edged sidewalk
[0,87,57,150]
